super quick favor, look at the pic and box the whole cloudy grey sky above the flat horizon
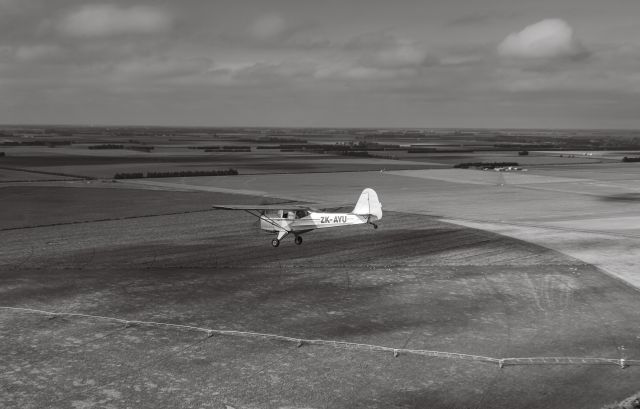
[0,0,640,129]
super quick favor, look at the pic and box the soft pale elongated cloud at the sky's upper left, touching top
[58,4,172,37]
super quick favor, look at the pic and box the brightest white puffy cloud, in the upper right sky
[498,19,588,59]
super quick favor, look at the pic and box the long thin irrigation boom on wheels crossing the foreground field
[0,306,640,368]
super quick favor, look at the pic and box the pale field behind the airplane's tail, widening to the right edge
[149,163,640,286]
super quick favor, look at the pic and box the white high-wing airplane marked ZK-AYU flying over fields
[212,188,382,247]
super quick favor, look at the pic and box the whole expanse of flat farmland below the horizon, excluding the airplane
[0,130,640,409]
